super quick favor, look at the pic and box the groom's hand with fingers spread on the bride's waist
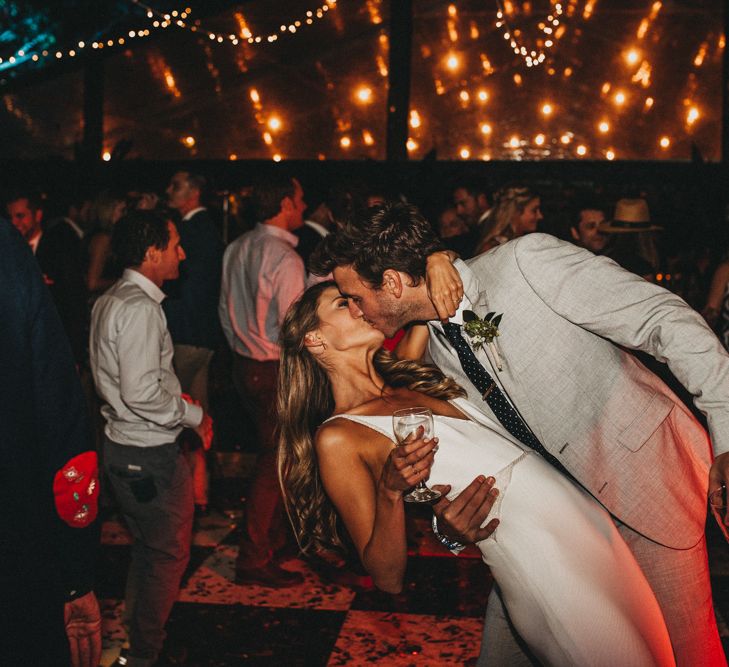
[433,475,499,544]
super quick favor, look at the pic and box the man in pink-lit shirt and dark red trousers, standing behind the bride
[218,176,306,587]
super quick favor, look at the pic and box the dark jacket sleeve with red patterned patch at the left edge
[0,222,98,597]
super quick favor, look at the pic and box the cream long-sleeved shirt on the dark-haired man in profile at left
[89,269,203,447]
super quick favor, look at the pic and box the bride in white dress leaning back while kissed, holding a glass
[278,282,674,667]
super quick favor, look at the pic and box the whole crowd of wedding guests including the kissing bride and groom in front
[0,171,729,667]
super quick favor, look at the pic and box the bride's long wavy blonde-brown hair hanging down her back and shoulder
[277,281,465,556]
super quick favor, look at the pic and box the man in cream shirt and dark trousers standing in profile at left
[89,211,211,667]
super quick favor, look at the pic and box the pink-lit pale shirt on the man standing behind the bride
[218,223,306,361]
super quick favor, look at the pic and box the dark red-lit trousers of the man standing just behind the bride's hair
[233,354,286,569]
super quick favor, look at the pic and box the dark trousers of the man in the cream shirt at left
[104,438,194,666]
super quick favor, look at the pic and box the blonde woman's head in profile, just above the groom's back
[474,185,543,256]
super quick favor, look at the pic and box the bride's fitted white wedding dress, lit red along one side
[334,399,675,667]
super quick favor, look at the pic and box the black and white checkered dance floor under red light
[97,456,729,667]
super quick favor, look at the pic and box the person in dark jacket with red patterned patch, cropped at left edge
[0,221,101,667]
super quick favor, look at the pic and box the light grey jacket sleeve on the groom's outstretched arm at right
[512,234,729,454]
